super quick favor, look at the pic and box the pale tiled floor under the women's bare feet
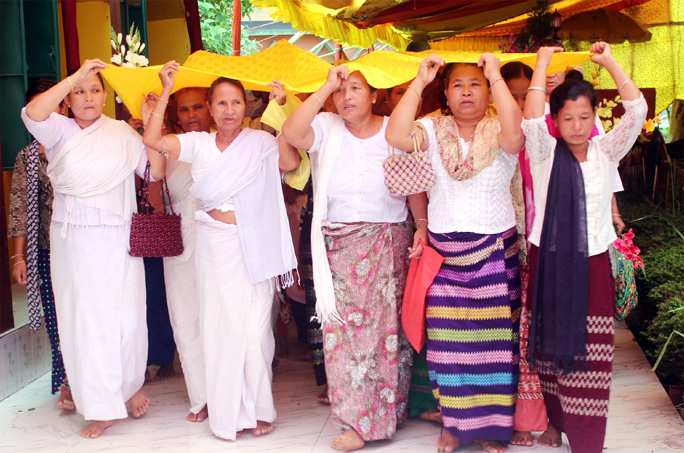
[0,328,684,453]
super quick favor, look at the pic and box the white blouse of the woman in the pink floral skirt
[309,113,408,223]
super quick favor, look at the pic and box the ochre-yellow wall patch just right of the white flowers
[147,17,190,66]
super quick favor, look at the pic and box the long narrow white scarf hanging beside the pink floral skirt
[311,115,346,323]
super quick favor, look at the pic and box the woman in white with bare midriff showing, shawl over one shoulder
[143,62,299,440]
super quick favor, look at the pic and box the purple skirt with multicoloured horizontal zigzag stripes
[426,224,521,444]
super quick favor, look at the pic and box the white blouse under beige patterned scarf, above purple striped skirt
[418,118,518,234]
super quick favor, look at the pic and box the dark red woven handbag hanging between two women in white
[128,162,183,258]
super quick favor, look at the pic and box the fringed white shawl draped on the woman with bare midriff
[190,129,297,288]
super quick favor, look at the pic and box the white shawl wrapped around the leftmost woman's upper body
[47,115,144,237]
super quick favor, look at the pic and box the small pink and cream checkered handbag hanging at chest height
[382,132,437,196]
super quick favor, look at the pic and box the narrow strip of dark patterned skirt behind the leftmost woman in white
[38,249,68,393]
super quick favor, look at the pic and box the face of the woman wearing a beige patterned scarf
[444,65,491,120]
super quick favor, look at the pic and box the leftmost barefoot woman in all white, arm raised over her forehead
[21,60,165,438]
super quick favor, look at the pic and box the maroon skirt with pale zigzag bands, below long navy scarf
[528,246,615,453]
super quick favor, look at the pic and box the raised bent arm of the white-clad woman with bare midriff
[143,61,180,159]
